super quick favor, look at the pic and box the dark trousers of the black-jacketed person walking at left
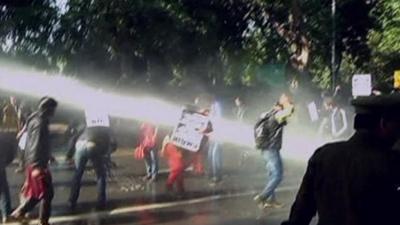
[17,169,54,223]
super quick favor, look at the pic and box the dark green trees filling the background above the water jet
[0,0,400,92]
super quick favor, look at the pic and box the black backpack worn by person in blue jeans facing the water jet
[254,110,278,150]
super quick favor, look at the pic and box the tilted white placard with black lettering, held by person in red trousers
[171,110,209,152]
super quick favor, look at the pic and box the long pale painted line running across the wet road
[7,186,298,225]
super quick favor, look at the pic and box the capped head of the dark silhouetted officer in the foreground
[352,95,400,143]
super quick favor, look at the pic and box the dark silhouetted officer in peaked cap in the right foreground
[282,95,400,225]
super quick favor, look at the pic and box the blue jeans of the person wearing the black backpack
[260,149,283,201]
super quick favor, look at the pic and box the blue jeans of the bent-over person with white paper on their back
[69,146,107,207]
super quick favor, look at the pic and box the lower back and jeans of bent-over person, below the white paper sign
[69,127,112,210]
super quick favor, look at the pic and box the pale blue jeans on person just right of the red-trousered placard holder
[207,140,222,180]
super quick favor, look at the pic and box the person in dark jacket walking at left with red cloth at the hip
[12,97,57,225]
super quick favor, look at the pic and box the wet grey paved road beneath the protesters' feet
[3,146,318,225]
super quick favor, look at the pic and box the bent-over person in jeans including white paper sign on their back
[69,109,116,211]
